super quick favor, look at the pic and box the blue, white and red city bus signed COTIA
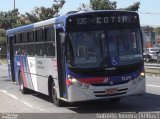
[7,10,146,106]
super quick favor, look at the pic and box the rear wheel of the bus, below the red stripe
[19,72,28,94]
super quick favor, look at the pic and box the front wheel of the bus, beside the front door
[52,82,63,107]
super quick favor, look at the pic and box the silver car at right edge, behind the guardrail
[143,48,160,62]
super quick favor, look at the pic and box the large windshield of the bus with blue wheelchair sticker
[68,29,143,68]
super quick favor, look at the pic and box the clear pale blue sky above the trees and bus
[0,0,160,27]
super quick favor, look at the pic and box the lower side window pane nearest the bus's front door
[44,43,55,57]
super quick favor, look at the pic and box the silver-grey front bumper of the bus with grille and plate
[68,76,146,102]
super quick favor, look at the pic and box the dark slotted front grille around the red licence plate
[93,88,128,97]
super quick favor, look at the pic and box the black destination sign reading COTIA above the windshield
[67,14,139,26]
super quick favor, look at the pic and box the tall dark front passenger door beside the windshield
[57,29,67,98]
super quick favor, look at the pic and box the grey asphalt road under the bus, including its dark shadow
[0,65,160,119]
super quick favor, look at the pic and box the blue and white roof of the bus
[7,10,138,35]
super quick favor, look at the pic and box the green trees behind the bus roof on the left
[0,0,65,30]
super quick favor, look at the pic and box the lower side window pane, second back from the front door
[35,43,44,56]
